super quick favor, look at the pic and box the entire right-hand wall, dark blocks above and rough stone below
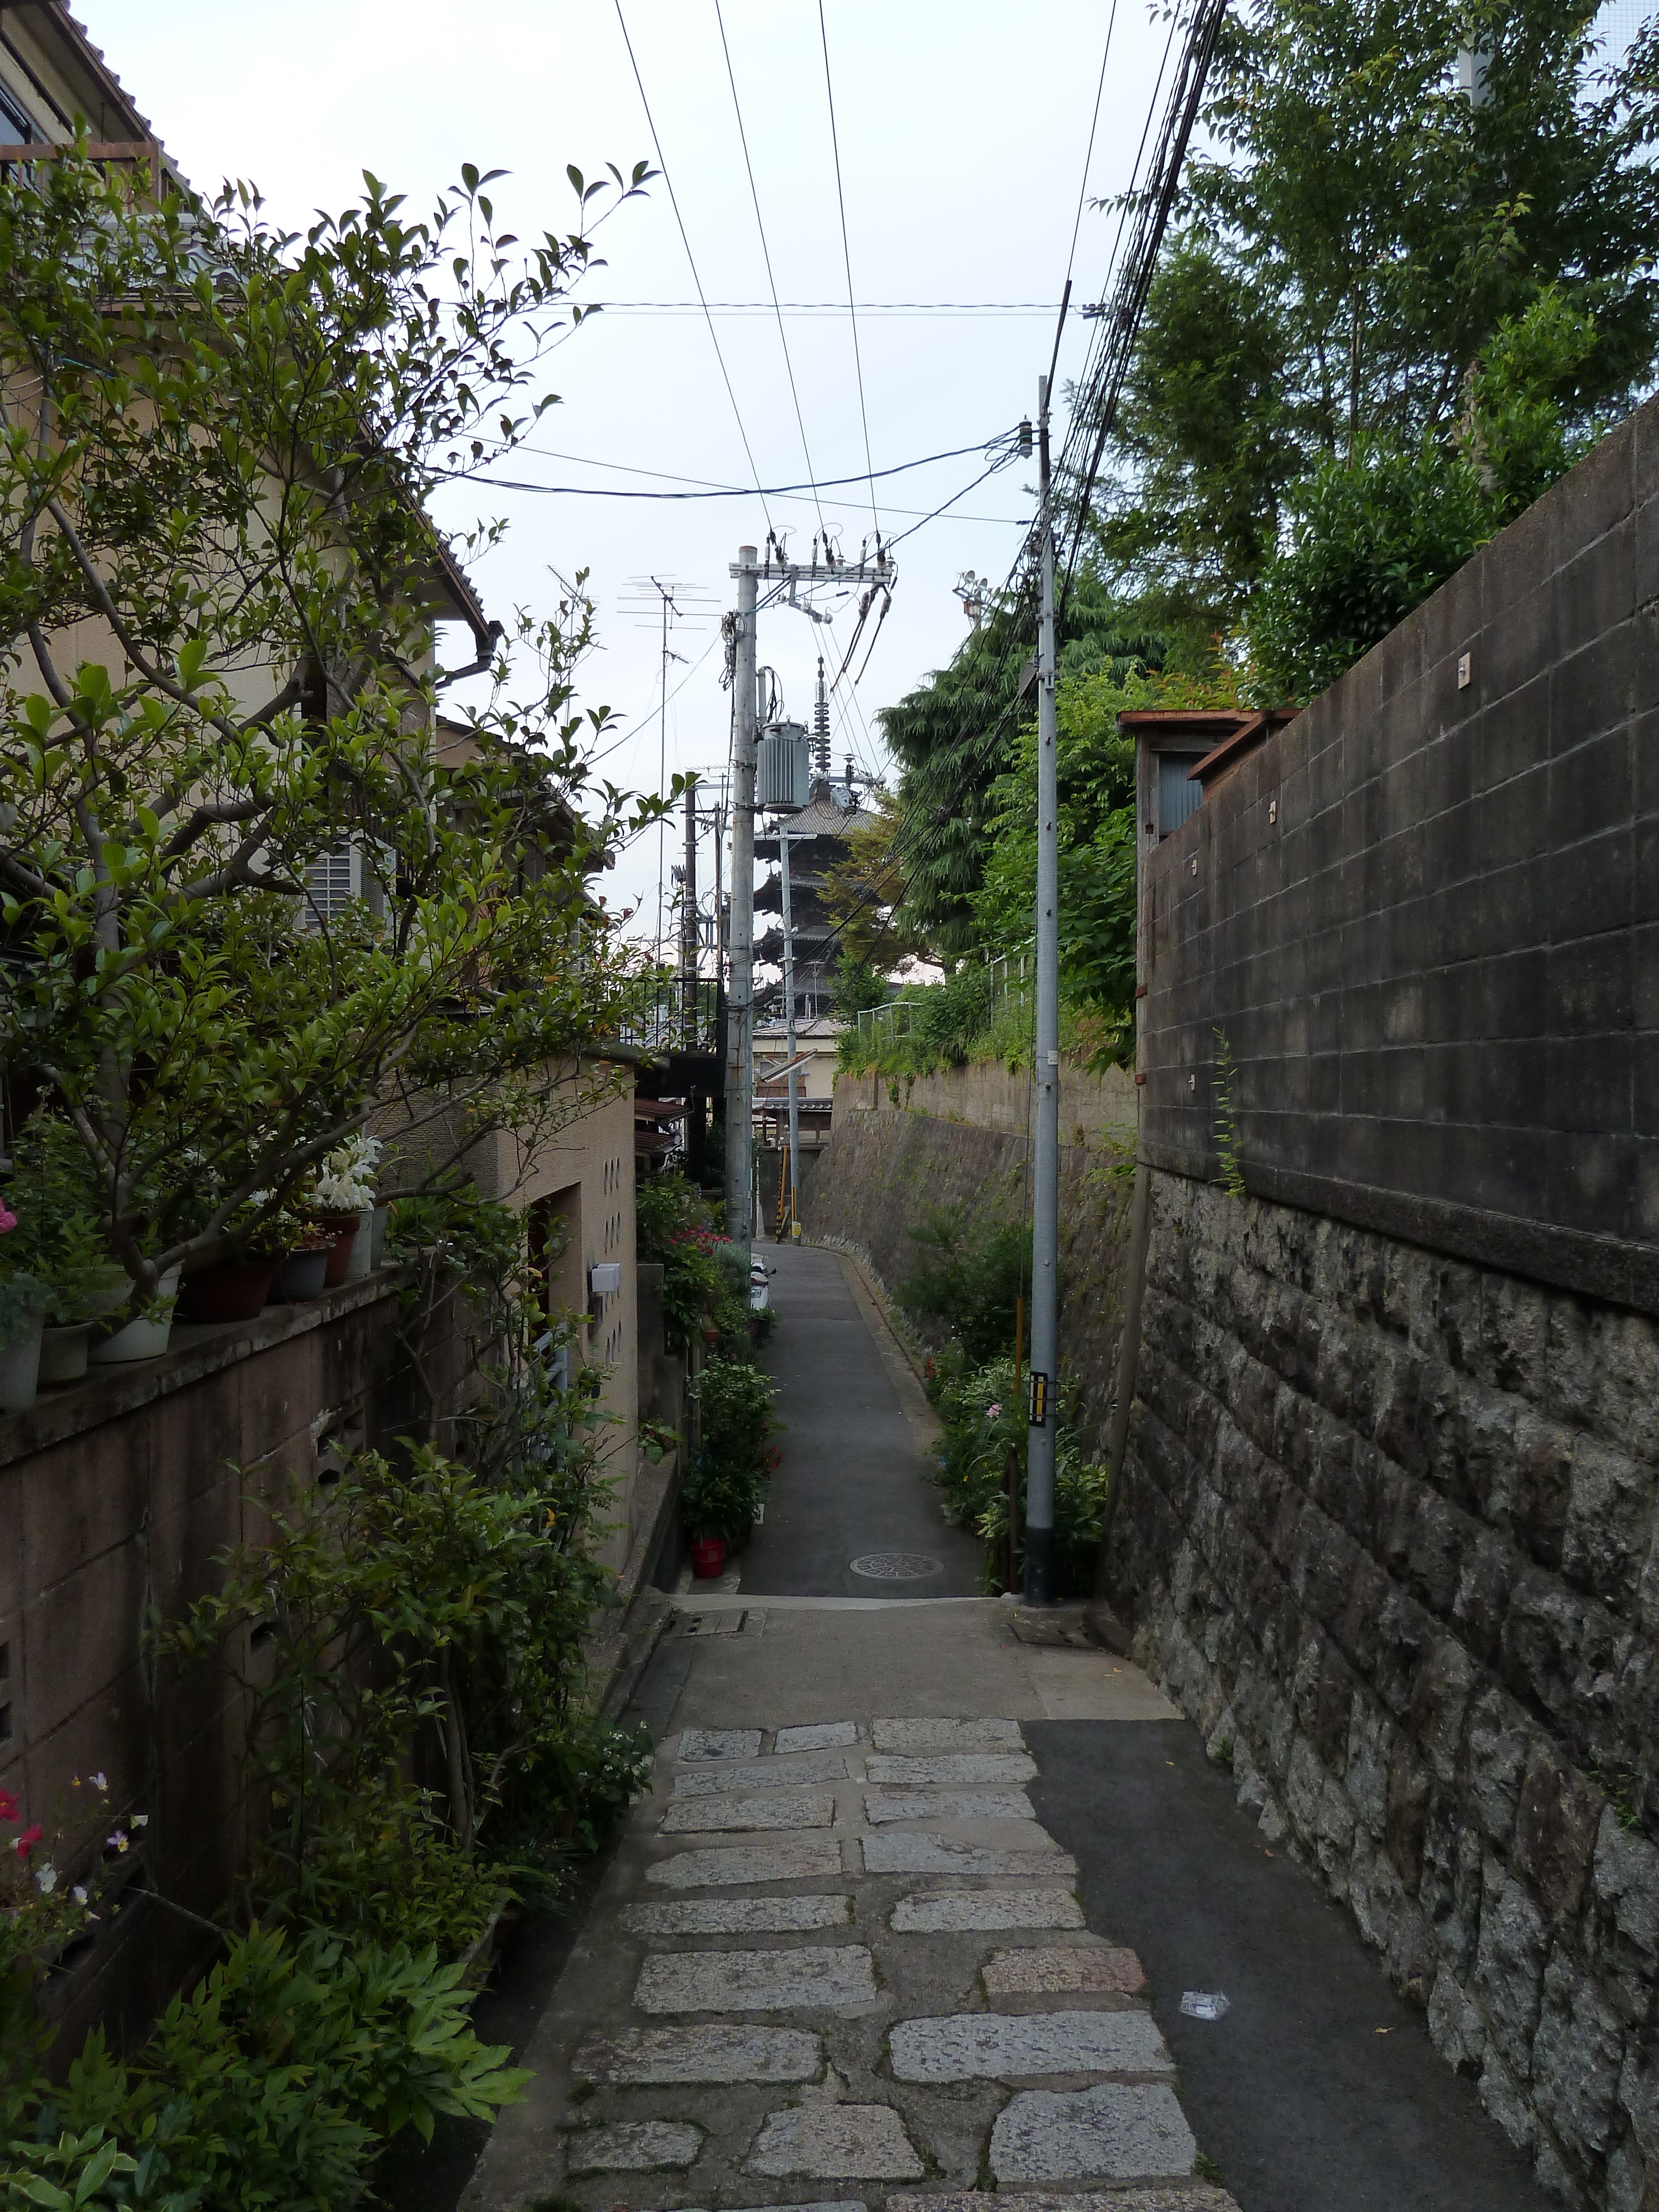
[1133,405,1659,2212]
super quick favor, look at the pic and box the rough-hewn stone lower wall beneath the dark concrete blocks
[1110,1175,1659,2212]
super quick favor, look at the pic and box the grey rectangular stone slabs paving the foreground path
[465,1708,1237,2212]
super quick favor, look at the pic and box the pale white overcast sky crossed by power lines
[75,0,1168,936]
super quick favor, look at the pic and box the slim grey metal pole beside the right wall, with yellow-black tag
[1024,376,1060,1606]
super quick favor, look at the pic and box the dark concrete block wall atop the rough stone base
[1139,400,1659,1312]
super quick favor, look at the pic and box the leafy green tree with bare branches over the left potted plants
[0,159,668,1294]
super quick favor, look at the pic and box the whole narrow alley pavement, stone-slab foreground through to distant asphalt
[460,1248,1544,2212]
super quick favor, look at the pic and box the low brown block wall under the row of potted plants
[0,1270,471,2062]
